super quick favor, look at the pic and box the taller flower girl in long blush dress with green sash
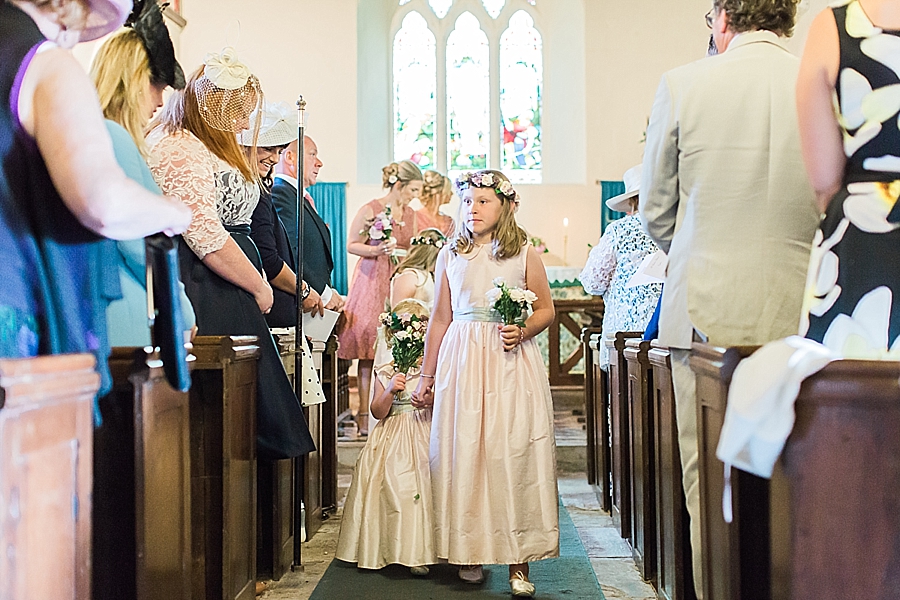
[413,171,559,597]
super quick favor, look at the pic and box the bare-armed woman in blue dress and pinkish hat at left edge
[0,0,191,388]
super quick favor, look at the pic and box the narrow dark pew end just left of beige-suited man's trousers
[647,342,696,600]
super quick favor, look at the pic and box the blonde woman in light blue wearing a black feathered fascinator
[90,0,195,347]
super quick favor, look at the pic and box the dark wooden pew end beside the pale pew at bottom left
[92,348,191,600]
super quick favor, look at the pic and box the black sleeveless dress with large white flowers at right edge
[801,0,900,358]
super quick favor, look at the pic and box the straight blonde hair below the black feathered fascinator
[90,29,152,157]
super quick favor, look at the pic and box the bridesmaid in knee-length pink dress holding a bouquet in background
[338,160,422,433]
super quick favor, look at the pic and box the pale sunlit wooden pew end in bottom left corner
[0,354,100,600]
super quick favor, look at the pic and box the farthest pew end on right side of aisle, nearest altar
[582,327,612,512]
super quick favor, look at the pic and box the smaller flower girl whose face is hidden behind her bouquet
[335,299,437,576]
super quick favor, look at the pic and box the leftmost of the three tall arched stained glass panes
[394,11,437,168]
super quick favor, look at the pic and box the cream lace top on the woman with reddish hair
[147,128,259,259]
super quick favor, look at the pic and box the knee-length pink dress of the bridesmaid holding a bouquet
[338,200,416,360]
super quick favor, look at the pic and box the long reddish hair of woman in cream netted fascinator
[150,66,262,183]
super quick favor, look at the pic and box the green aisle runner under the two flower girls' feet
[310,505,603,600]
